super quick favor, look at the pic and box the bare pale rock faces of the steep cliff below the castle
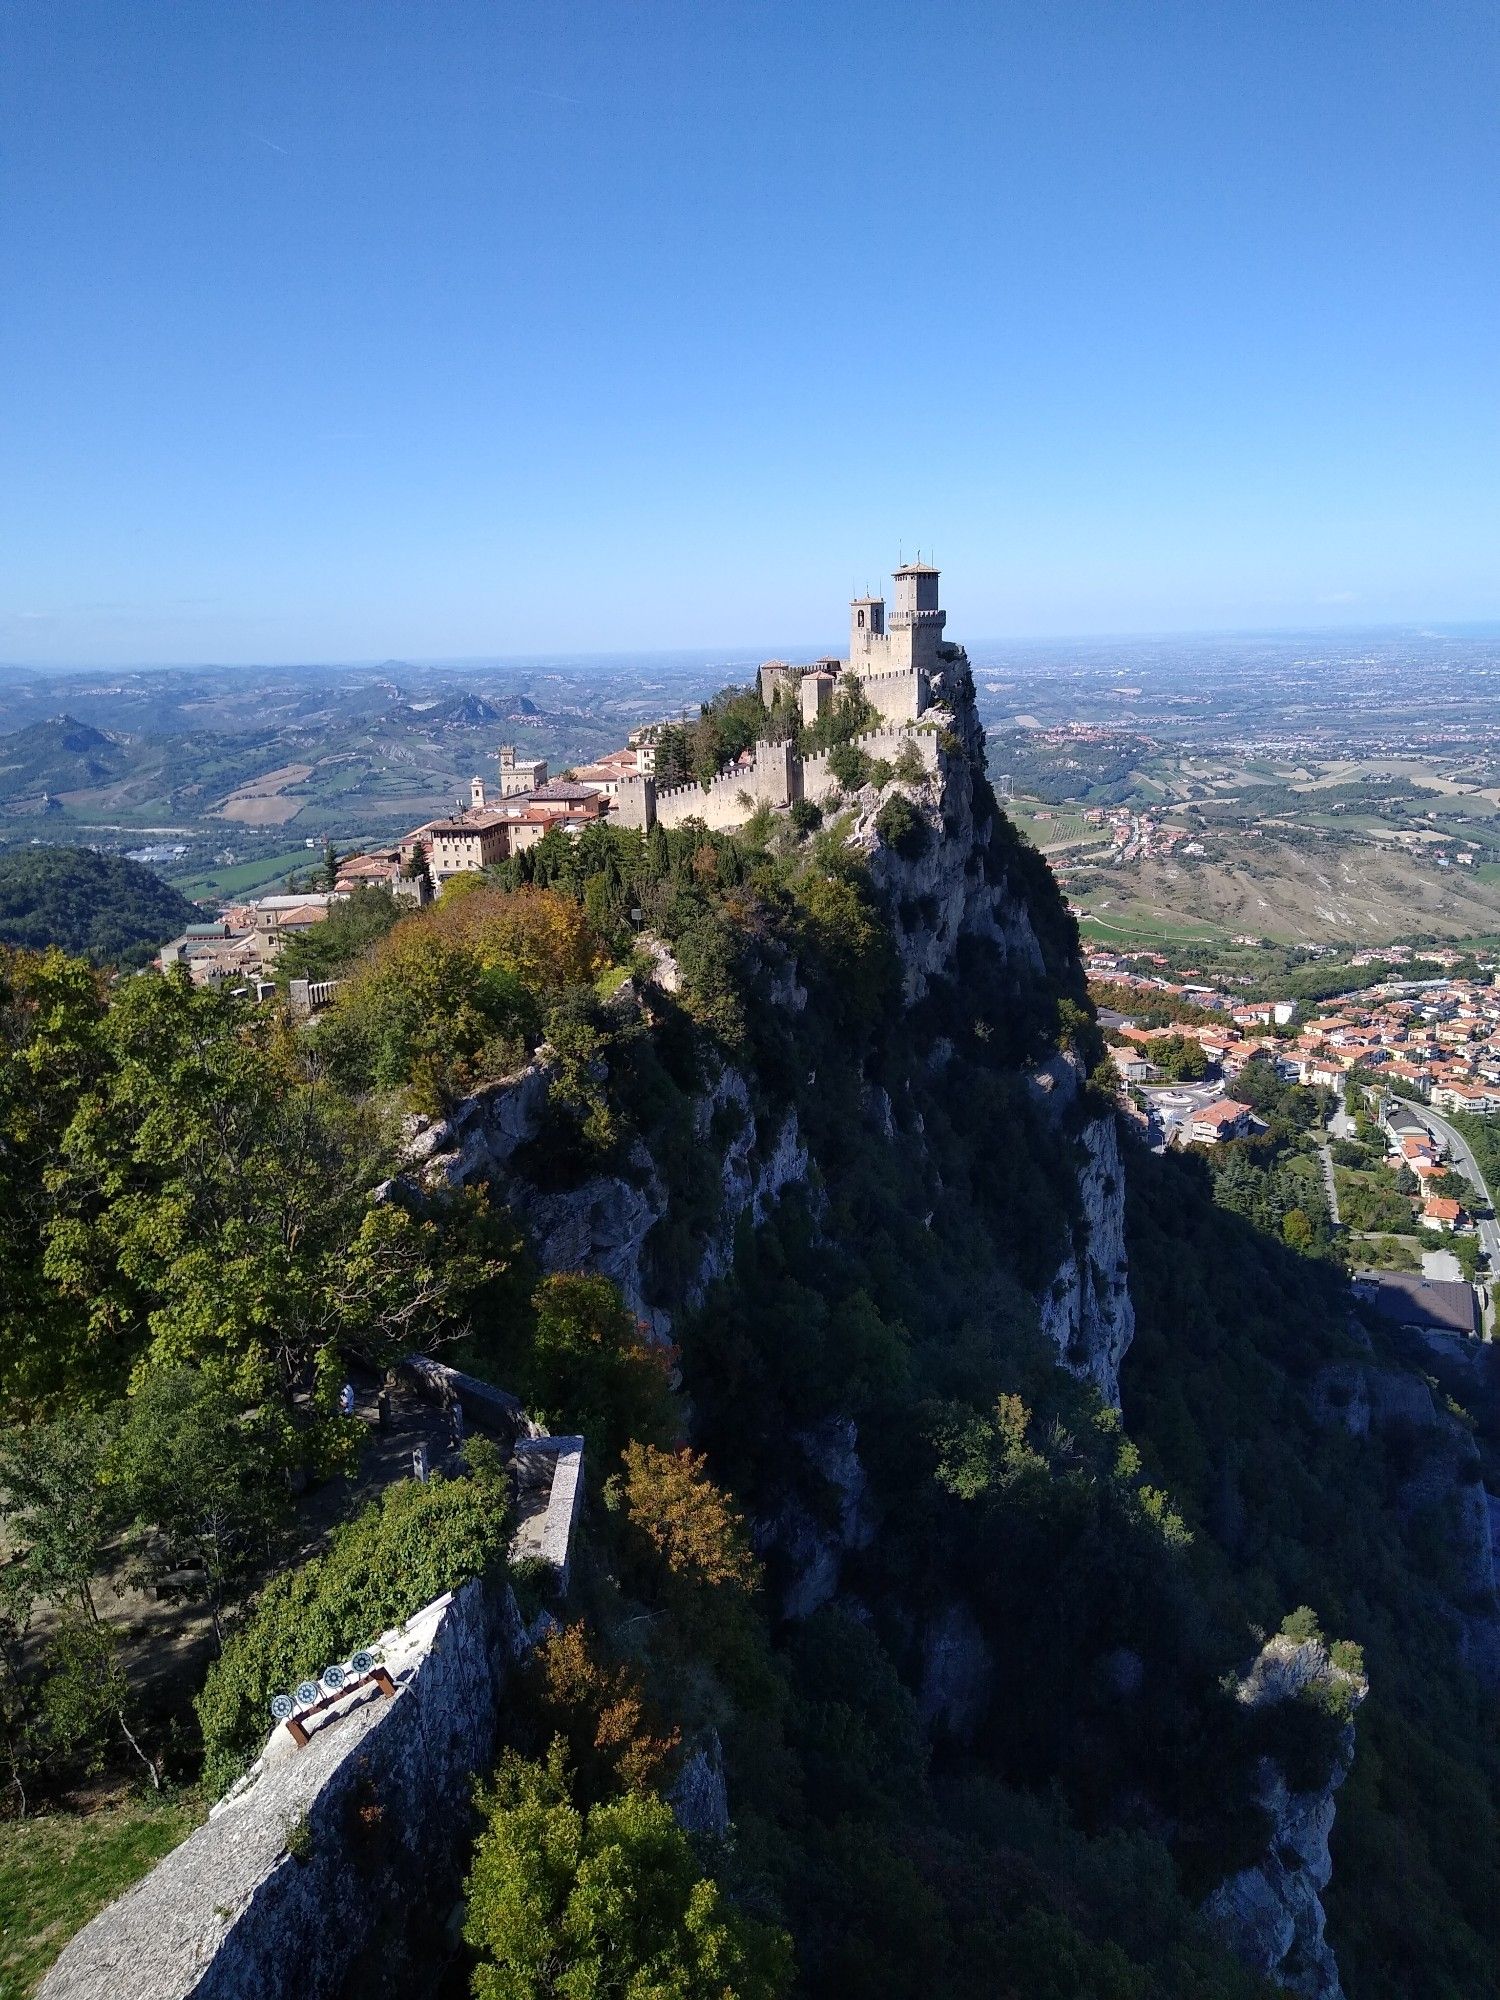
[408,648,1132,1406]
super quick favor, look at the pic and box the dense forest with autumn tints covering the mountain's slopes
[0,696,1500,2000]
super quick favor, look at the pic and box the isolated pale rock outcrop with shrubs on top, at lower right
[1204,1636,1366,2000]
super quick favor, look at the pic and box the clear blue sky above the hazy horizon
[0,0,1500,664]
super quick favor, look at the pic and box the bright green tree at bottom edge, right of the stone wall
[464,1744,792,2000]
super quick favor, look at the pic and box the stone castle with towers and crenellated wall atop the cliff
[614,562,948,830]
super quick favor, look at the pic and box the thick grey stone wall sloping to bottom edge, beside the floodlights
[40,1582,520,2000]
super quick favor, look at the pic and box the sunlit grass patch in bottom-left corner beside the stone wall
[0,1796,204,2000]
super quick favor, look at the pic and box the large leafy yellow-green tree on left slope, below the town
[44,976,506,1394]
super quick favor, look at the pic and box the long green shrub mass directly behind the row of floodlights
[196,1466,508,1792]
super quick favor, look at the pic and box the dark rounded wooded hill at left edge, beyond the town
[0,846,198,966]
